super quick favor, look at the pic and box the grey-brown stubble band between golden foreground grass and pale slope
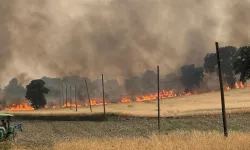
[0,113,250,150]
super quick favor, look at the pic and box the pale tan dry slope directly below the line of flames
[2,88,250,117]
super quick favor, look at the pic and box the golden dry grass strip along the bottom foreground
[9,131,250,150]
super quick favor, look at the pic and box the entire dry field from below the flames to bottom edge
[0,88,250,150]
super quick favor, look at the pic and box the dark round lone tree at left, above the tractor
[25,79,49,109]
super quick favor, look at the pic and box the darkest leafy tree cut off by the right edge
[233,46,250,83]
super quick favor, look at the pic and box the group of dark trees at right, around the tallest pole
[181,46,250,91]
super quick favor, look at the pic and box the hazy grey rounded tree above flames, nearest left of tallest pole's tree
[180,64,205,92]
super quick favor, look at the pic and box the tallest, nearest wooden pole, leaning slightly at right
[215,42,228,137]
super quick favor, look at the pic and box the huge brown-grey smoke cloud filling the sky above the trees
[0,0,250,86]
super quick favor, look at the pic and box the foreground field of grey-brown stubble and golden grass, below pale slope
[0,113,250,150]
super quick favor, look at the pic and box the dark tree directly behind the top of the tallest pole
[203,46,237,88]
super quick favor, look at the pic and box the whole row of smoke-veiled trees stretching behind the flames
[0,46,250,109]
